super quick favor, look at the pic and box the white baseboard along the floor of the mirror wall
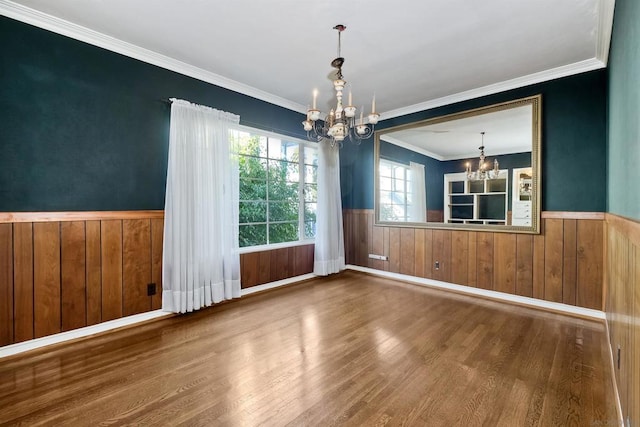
[346,264,606,320]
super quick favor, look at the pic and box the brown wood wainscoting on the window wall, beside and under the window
[0,210,313,346]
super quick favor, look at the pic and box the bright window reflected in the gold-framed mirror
[379,159,412,221]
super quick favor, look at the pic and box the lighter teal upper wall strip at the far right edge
[607,0,640,220]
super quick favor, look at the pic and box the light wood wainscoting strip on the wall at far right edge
[605,214,640,426]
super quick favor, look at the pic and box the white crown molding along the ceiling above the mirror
[381,58,606,120]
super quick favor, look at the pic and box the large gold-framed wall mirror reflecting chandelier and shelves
[374,95,542,234]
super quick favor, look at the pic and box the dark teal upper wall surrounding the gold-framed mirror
[340,70,604,212]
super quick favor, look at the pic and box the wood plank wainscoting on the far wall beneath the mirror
[344,209,604,310]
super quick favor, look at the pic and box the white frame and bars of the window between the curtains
[230,125,319,254]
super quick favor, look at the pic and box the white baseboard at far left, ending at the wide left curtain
[0,310,173,359]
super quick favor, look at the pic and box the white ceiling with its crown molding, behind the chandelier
[0,0,615,119]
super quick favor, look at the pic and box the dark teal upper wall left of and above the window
[0,17,305,212]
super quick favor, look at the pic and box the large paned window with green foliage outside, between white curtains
[230,129,318,247]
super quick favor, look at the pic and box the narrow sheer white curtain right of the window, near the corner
[313,142,344,276]
